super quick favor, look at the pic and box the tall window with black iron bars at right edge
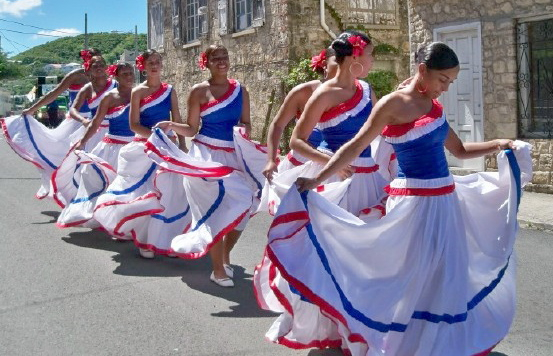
[517,19,553,139]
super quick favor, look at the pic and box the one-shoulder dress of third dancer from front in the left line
[52,104,134,228]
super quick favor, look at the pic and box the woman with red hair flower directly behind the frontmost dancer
[254,31,389,348]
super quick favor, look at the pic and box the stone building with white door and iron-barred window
[408,0,553,193]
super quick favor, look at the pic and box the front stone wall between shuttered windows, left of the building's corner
[148,0,289,138]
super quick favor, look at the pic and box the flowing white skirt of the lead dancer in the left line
[141,129,266,258]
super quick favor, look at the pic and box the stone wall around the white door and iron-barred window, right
[409,0,553,193]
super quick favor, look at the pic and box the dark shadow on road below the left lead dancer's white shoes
[182,264,278,318]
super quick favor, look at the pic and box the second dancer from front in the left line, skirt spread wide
[94,49,196,258]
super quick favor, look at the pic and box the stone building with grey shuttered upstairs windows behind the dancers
[148,0,409,139]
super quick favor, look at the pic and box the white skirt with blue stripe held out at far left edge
[0,115,106,199]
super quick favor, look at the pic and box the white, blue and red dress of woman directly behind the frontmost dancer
[254,82,389,348]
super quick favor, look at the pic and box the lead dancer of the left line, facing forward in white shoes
[154,45,267,287]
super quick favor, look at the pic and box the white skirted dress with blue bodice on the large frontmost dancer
[256,102,532,356]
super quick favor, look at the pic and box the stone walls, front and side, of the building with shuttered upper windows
[148,0,408,139]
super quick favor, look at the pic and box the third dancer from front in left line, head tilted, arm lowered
[52,63,134,227]
